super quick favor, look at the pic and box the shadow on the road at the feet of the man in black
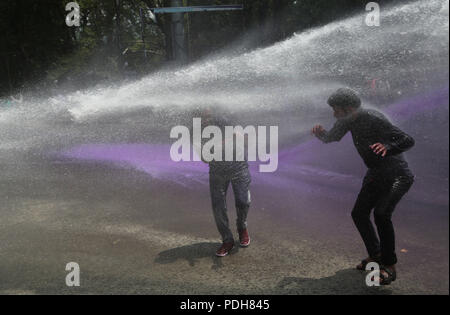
[277,269,392,295]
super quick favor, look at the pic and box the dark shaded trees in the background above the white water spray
[0,0,400,96]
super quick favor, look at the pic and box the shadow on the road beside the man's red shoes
[155,243,237,269]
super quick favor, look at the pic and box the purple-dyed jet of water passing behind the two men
[60,87,449,202]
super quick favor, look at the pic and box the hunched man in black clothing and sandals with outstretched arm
[312,88,415,285]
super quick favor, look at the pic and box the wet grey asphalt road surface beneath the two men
[0,161,449,294]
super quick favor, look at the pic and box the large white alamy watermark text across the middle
[170,118,278,173]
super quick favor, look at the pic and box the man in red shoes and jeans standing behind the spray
[192,109,251,257]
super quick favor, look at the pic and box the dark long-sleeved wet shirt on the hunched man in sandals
[319,109,415,175]
